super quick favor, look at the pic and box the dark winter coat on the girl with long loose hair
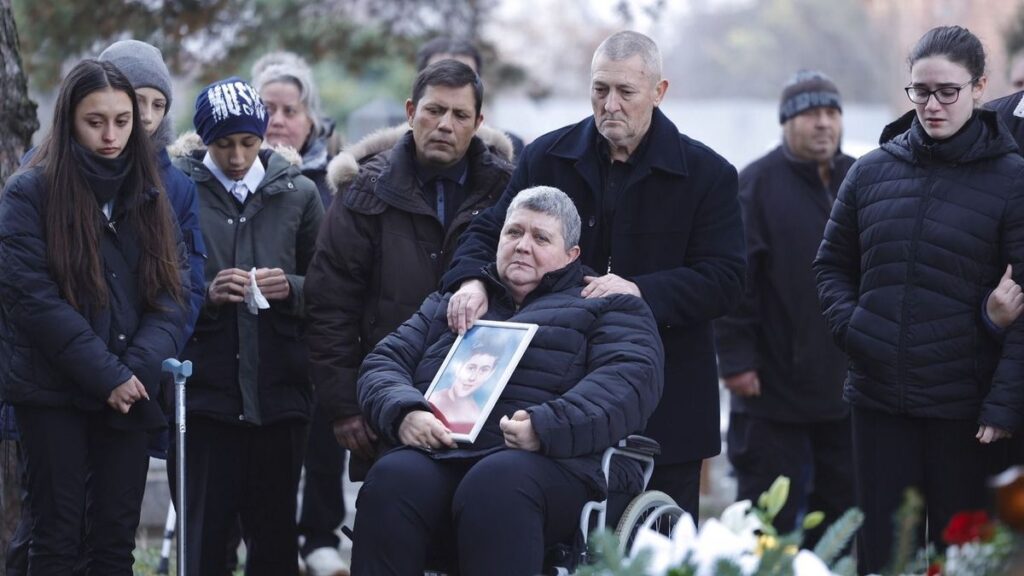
[0,167,188,429]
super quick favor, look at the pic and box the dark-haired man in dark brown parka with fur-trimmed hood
[306,59,512,480]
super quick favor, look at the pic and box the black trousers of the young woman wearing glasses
[852,407,987,574]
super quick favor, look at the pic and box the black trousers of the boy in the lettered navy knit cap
[168,416,306,576]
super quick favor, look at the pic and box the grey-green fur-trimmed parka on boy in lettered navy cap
[171,133,324,425]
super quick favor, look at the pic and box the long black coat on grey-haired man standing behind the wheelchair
[443,109,745,463]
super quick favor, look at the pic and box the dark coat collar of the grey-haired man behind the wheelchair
[549,108,688,190]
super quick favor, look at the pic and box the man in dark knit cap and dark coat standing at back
[715,71,853,538]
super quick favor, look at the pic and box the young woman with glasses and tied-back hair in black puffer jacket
[814,26,1024,573]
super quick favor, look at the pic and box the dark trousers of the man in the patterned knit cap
[728,412,854,547]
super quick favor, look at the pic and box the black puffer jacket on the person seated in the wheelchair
[357,262,665,496]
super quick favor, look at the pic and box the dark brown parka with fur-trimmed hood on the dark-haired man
[306,127,512,420]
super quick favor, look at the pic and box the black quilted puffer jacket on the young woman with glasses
[814,111,1024,430]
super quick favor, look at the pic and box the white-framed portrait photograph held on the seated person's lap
[424,320,537,444]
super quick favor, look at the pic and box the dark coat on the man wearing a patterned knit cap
[715,145,853,422]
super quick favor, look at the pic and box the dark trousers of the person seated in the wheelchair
[352,449,588,576]
